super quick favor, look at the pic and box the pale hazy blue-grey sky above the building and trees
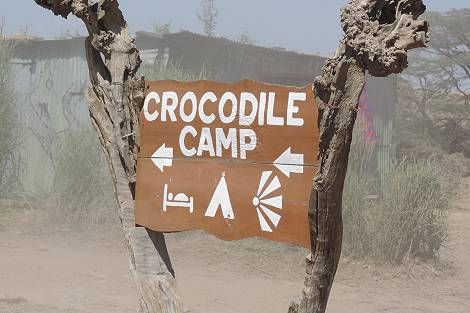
[0,0,470,54]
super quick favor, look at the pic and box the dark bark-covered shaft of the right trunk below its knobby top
[292,58,365,312]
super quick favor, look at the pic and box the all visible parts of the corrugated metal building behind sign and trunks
[13,32,397,193]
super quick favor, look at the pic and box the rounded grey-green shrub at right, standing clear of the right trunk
[371,159,455,263]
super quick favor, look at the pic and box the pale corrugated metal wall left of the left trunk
[13,40,90,193]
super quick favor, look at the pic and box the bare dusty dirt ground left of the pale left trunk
[0,233,137,313]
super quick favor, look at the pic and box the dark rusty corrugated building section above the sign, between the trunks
[137,31,325,87]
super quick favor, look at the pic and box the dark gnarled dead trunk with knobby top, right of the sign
[289,0,428,313]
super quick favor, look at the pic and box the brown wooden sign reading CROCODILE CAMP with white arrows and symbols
[136,80,319,248]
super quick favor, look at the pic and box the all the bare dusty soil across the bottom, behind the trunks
[0,177,470,313]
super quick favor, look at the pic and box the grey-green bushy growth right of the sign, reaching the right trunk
[343,125,455,264]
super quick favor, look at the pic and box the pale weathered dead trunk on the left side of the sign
[35,0,182,313]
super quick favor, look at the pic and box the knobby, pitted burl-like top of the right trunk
[341,0,428,76]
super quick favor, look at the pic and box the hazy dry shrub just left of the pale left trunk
[50,128,115,226]
